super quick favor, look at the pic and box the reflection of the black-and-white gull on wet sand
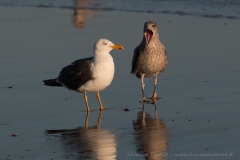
[46,111,117,160]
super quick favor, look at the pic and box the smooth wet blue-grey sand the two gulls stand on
[0,7,240,160]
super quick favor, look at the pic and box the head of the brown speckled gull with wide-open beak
[143,21,158,43]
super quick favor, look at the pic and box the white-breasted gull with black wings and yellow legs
[43,39,123,111]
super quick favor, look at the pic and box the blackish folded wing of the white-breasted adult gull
[58,57,93,90]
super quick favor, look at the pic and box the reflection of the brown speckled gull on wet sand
[133,102,169,160]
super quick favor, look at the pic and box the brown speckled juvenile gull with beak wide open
[131,22,168,102]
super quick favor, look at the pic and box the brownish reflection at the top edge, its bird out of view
[73,0,94,28]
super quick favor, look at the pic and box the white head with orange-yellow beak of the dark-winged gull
[94,38,124,53]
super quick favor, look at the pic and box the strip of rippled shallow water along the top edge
[0,0,240,19]
